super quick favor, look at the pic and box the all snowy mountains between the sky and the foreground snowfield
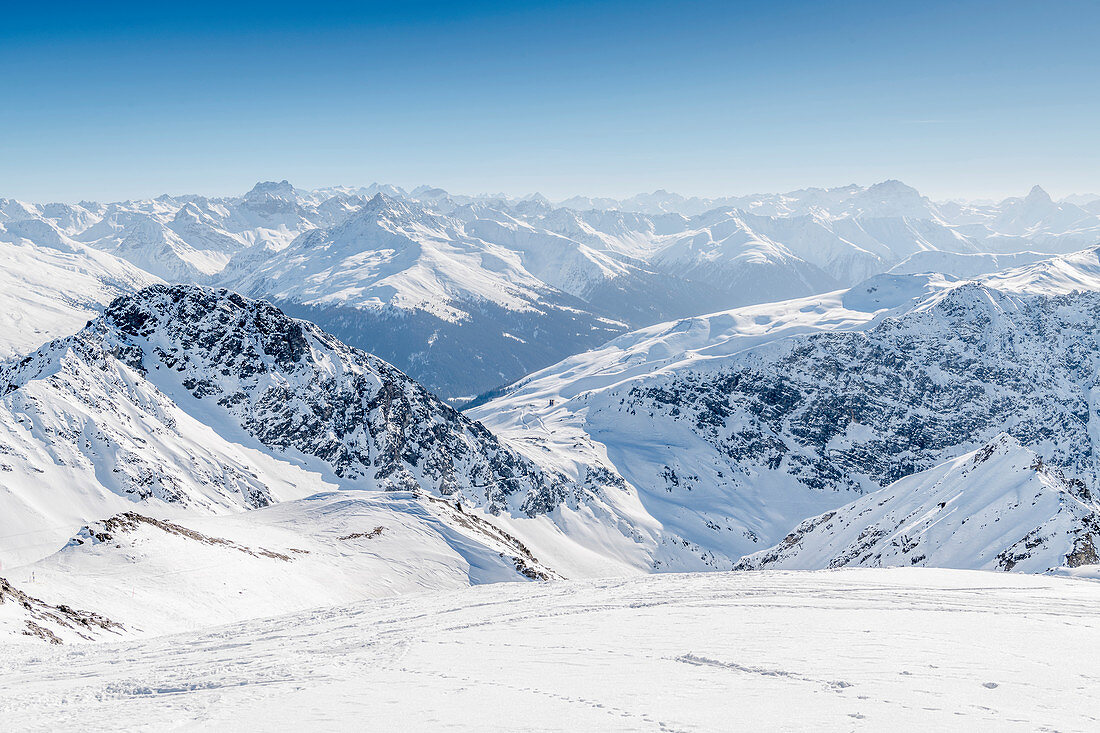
[0,182,1100,642]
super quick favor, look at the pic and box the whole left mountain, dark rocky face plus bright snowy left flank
[0,285,575,564]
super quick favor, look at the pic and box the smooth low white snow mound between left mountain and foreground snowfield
[0,491,551,641]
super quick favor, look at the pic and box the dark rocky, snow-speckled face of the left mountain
[88,285,565,506]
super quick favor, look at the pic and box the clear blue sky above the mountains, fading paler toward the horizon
[0,0,1100,200]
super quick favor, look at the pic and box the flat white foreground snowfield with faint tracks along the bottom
[0,569,1100,731]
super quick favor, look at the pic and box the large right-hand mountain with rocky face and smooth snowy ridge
[470,251,1100,568]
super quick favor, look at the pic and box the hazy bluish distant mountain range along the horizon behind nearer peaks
[0,180,1100,405]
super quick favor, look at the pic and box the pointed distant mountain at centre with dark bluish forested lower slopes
[221,193,625,396]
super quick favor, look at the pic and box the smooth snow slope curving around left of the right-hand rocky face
[469,275,950,570]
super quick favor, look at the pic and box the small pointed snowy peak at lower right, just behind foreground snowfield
[738,435,1100,572]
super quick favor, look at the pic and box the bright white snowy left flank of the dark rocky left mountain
[0,327,325,568]
